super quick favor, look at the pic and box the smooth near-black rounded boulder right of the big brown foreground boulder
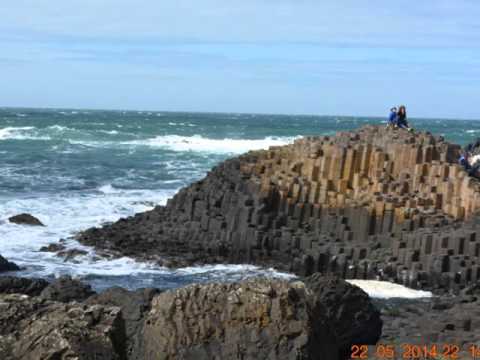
[305,273,383,355]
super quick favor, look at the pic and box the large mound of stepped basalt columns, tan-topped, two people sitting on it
[78,126,480,291]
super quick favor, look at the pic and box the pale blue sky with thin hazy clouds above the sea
[0,0,480,119]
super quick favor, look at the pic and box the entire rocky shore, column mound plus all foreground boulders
[0,126,480,360]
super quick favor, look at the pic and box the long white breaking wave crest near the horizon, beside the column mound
[123,135,297,154]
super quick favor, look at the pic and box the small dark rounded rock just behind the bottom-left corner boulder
[40,276,95,303]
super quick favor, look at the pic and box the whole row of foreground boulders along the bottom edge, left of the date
[0,275,381,360]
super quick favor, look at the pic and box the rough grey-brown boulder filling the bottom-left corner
[0,294,126,360]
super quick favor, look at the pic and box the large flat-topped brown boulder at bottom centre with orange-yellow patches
[143,279,338,360]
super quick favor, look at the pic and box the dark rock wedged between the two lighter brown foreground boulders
[86,287,160,360]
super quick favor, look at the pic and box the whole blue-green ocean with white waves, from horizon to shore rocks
[0,108,480,290]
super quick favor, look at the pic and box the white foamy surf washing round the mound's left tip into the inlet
[0,184,293,288]
